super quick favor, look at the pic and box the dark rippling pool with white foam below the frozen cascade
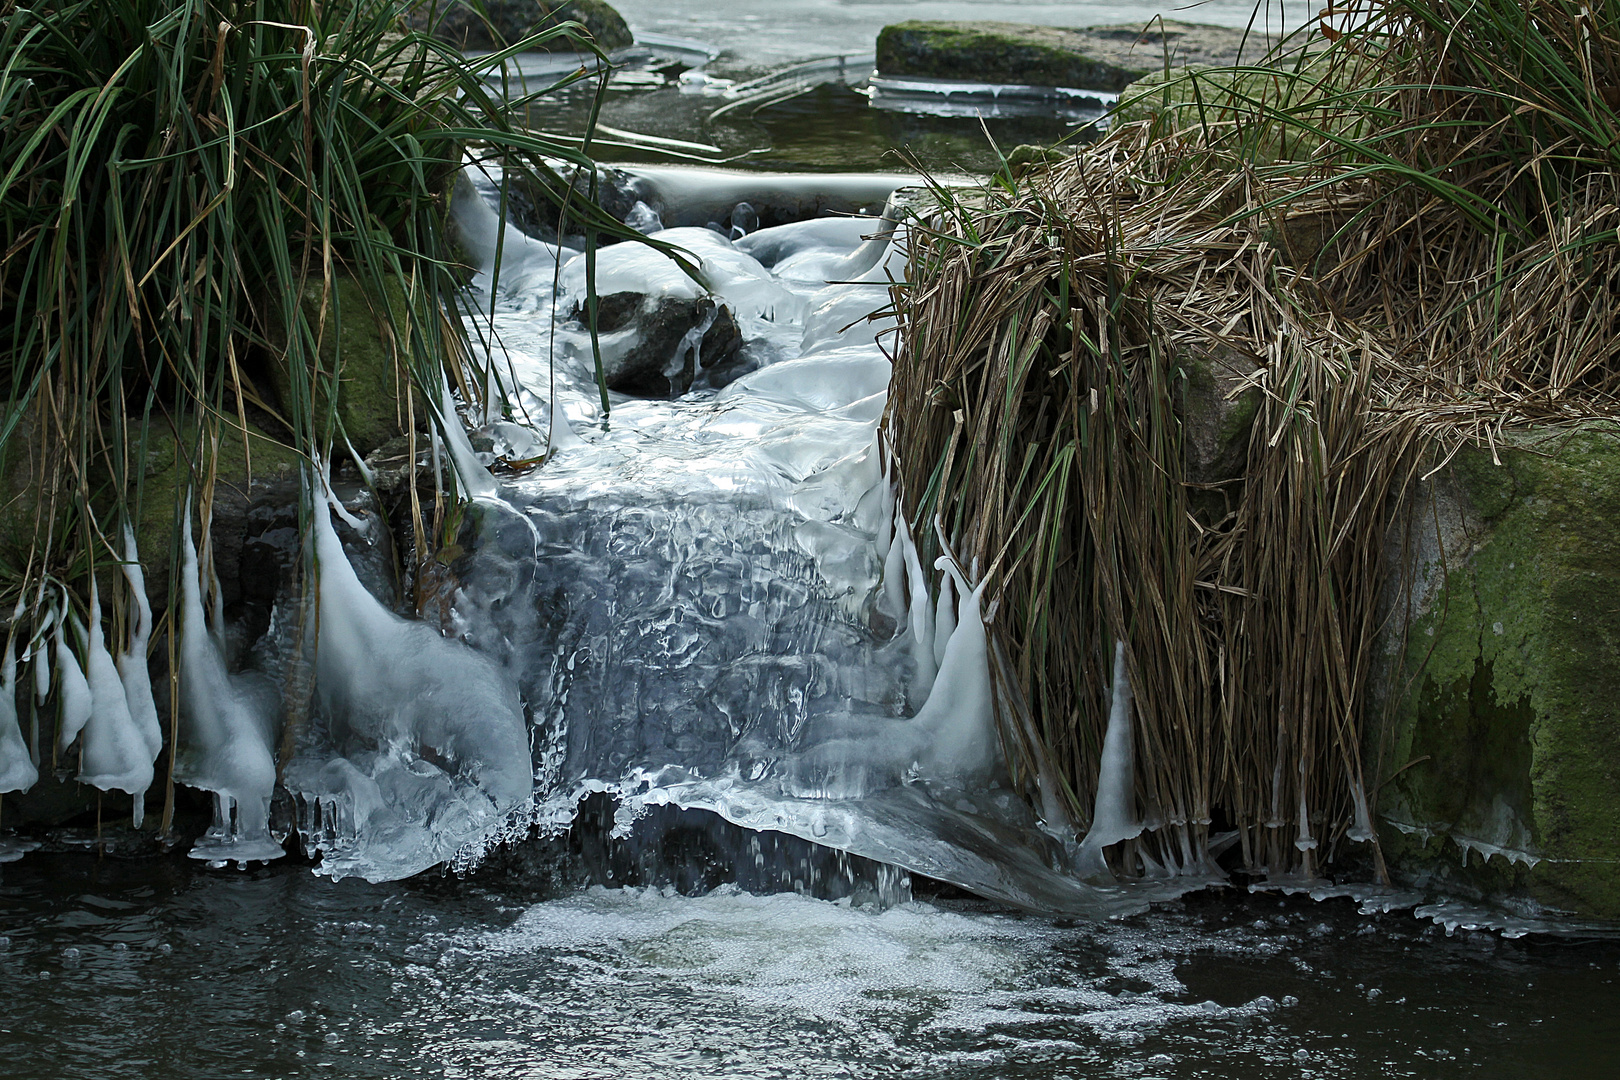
[0,855,1620,1078]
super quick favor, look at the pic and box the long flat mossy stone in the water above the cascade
[878,19,1268,94]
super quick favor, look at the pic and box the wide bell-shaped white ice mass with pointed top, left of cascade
[285,485,533,881]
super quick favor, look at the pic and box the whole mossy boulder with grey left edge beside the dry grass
[1367,423,1620,920]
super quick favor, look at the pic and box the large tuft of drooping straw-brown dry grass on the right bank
[886,0,1620,876]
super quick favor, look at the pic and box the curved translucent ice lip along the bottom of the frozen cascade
[535,771,1228,920]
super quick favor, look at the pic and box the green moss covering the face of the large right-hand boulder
[1382,424,1620,918]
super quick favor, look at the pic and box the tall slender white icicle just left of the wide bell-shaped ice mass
[175,500,284,861]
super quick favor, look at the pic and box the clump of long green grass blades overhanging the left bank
[0,0,618,599]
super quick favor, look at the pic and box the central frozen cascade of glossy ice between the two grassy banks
[427,172,1175,913]
